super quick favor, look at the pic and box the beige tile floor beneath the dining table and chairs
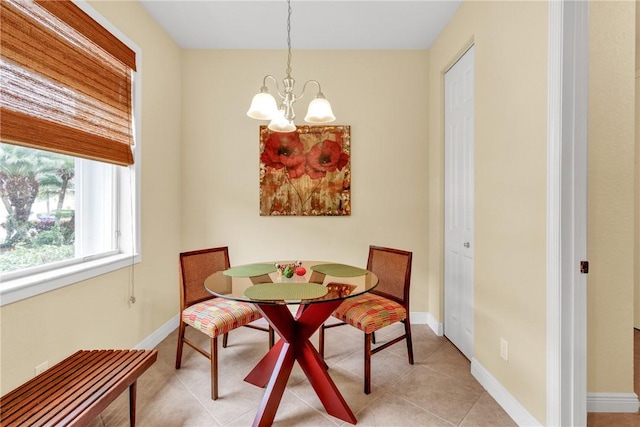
[90,325,640,427]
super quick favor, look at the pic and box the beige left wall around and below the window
[0,2,181,394]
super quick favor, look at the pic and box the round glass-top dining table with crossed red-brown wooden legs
[204,261,378,426]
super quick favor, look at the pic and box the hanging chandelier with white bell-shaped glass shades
[247,0,336,132]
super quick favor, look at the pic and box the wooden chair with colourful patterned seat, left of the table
[176,246,274,400]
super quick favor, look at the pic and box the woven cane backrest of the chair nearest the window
[180,246,230,311]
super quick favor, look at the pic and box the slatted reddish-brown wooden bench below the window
[0,350,158,427]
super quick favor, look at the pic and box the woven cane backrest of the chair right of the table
[367,246,413,310]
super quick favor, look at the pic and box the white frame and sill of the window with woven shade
[0,0,142,307]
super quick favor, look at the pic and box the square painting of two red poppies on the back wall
[260,125,351,216]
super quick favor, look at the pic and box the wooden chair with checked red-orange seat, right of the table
[318,246,413,394]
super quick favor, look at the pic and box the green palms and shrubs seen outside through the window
[0,144,75,272]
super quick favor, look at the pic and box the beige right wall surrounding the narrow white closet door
[429,2,548,423]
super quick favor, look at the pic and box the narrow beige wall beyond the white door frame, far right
[587,1,636,393]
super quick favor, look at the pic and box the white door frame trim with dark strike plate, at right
[546,0,589,426]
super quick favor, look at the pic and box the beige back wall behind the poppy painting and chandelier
[182,50,429,304]
